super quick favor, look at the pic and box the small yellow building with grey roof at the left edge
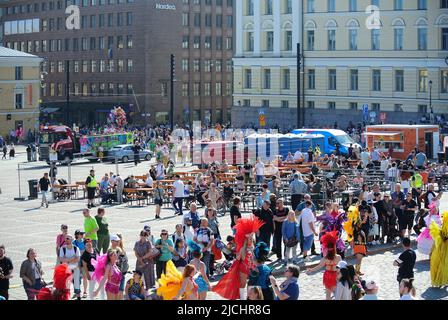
[0,46,42,137]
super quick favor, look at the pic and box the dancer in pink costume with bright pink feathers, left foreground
[92,249,123,300]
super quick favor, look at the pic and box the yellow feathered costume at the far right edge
[429,211,448,287]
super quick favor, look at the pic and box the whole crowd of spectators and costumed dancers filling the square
[0,124,448,300]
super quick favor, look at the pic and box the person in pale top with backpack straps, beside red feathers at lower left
[59,234,81,300]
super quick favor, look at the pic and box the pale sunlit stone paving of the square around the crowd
[0,147,448,300]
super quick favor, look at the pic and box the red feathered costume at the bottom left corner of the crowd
[37,264,73,300]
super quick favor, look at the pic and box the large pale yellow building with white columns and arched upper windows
[233,0,448,129]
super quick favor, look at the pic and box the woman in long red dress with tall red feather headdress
[213,215,264,300]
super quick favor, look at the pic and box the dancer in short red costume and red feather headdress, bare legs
[306,231,342,300]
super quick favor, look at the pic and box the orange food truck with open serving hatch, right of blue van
[364,124,440,160]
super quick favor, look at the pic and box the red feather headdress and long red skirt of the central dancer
[212,215,264,300]
